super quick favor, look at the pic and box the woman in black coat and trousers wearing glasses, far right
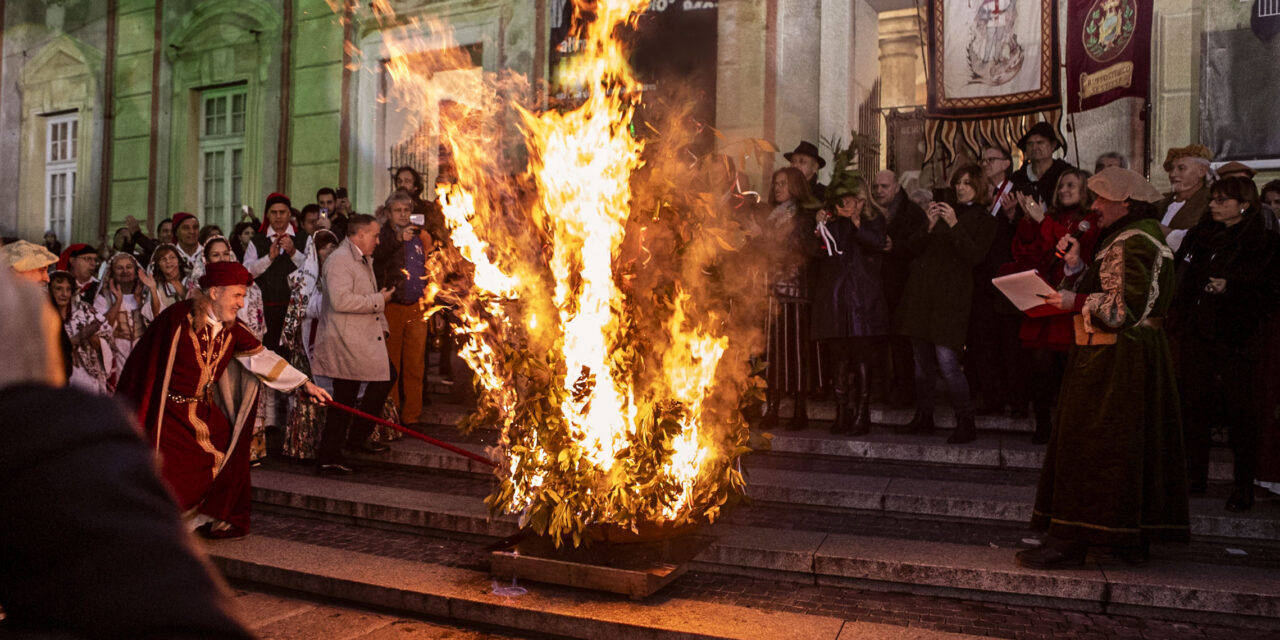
[1170,177,1277,511]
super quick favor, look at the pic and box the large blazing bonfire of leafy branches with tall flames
[374,0,762,545]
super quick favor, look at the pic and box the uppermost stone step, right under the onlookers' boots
[411,406,1231,481]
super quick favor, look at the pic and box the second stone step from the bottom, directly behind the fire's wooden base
[244,471,1280,625]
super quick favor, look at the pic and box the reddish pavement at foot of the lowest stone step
[227,588,536,640]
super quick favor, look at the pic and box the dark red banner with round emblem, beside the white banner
[1066,0,1152,113]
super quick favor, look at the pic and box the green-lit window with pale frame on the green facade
[200,84,248,229]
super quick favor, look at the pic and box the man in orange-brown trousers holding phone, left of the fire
[374,189,433,425]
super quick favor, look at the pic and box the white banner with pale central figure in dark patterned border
[928,0,1061,120]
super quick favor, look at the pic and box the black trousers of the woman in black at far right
[1179,335,1262,490]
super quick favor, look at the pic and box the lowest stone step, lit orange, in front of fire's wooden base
[206,536,952,640]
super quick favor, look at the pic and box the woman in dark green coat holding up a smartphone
[895,164,996,444]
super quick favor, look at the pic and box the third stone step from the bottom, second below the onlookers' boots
[343,436,1280,541]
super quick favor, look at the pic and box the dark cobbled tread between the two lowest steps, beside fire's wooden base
[253,513,1275,640]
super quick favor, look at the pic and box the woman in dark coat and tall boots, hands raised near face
[810,178,888,435]
